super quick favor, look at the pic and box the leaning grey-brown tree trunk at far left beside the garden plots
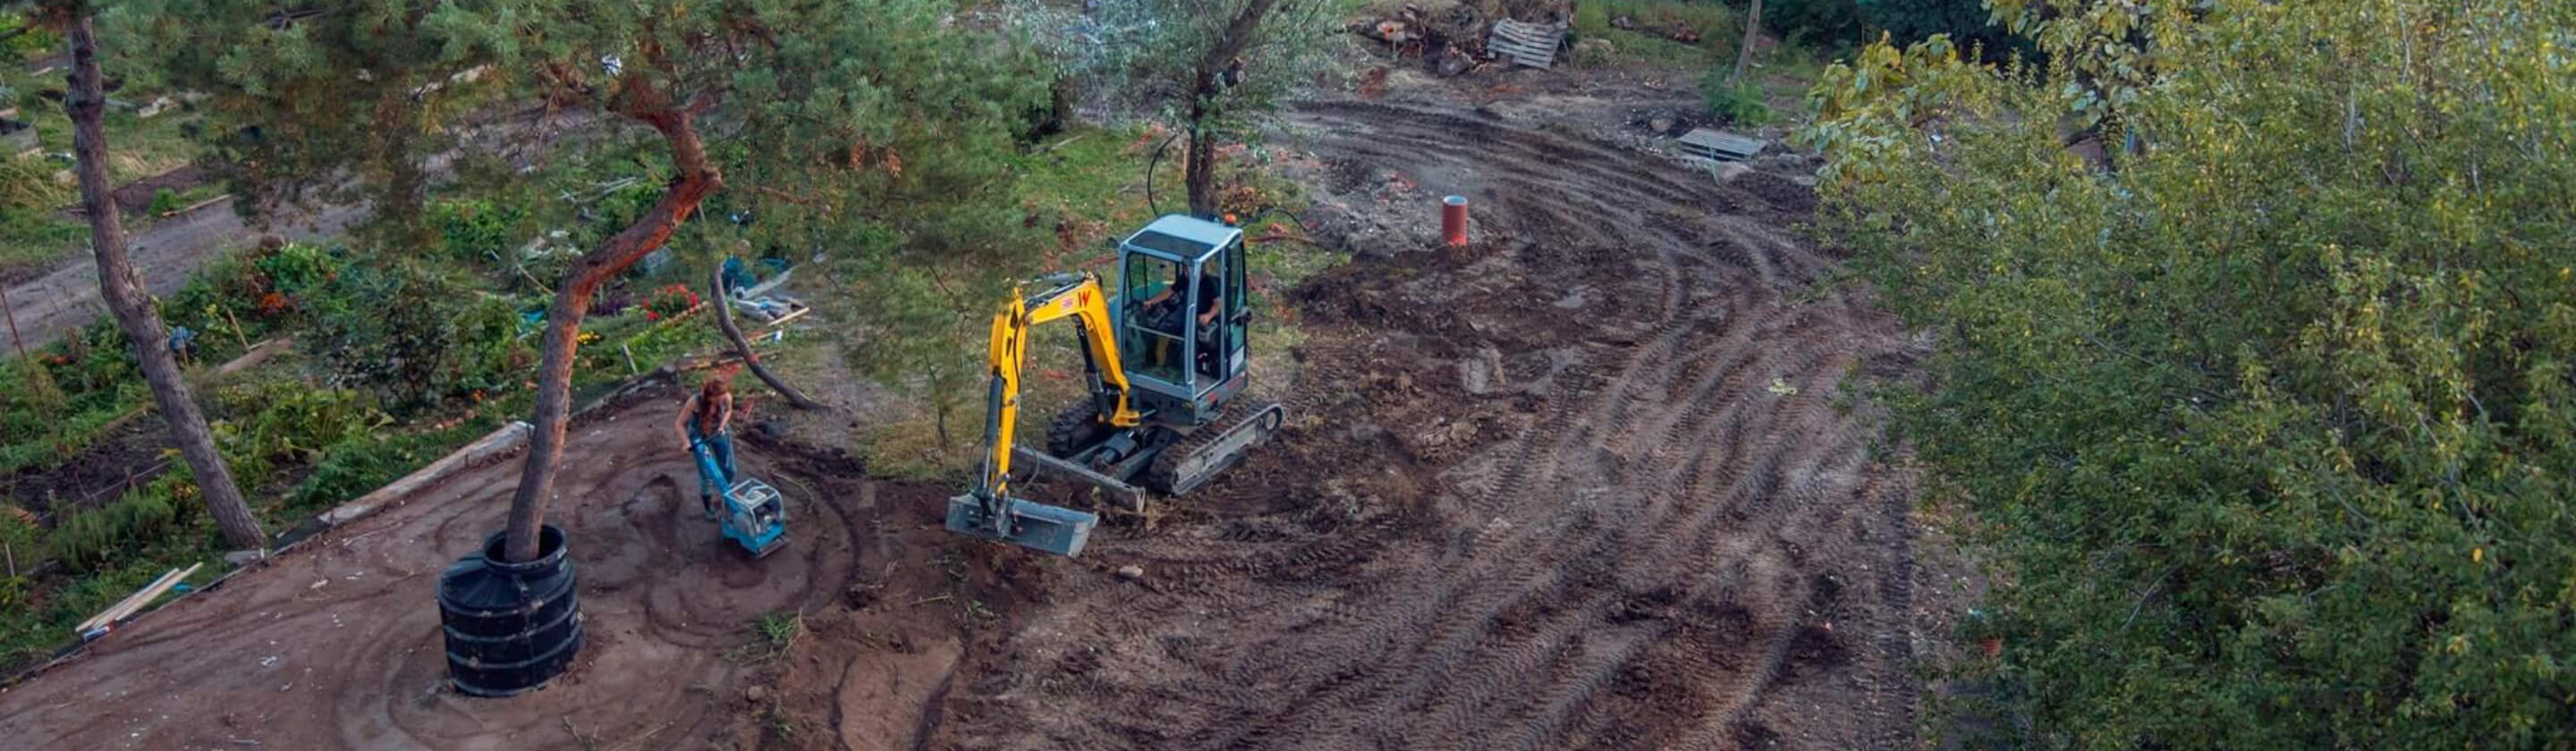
[62,15,268,551]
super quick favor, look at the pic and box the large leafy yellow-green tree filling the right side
[1806,0,2576,748]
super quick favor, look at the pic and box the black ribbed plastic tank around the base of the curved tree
[438,525,582,697]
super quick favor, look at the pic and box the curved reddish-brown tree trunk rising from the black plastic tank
[503,82,724,561]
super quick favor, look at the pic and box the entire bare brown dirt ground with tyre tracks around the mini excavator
[0,62,1950,748]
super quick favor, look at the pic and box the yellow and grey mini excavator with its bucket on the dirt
[948,214,1285,555]
